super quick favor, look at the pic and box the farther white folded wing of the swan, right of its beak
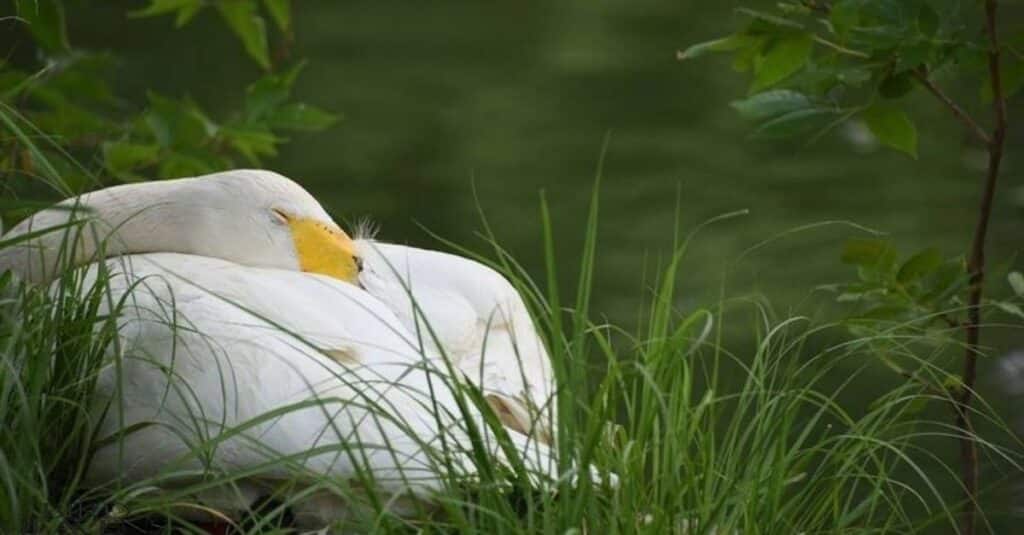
[355,239,556,444]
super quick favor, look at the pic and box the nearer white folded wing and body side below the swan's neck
[79,253,555,526]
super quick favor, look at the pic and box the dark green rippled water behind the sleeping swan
[18,0,1024,524]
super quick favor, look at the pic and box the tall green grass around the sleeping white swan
[0,106,1022,534]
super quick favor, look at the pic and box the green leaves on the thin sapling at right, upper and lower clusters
[678,0,1024,390]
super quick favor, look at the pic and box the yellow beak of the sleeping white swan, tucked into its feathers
[288,218,359,284]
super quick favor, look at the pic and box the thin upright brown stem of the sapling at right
[955,4,1007,535]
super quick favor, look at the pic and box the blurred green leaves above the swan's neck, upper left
[0,0,337,194]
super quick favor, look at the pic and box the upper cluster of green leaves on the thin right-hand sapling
[678,0,1024,158]
